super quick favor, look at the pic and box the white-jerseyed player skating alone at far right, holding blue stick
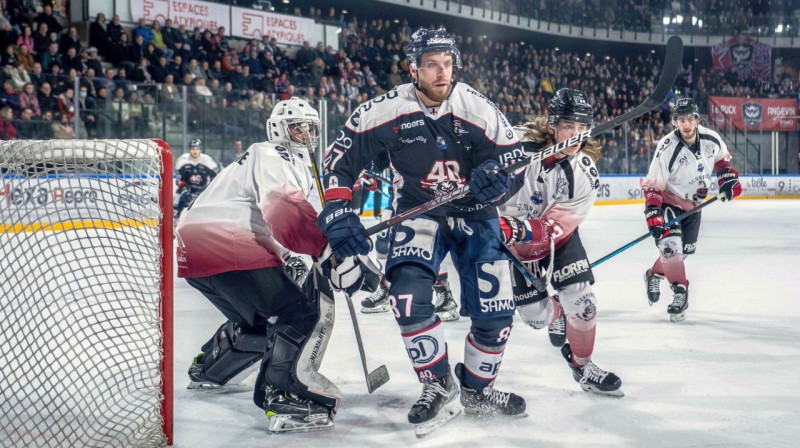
[641,98,742,322]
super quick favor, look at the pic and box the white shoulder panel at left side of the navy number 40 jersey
[345,84,412,132]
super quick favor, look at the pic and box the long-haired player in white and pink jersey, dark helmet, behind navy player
[499,88,622,396]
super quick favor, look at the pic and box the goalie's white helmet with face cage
[267,96,319,152]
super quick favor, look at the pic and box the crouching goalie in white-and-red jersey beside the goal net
[177,98,372,432]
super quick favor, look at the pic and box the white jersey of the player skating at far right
[640,125,731,210]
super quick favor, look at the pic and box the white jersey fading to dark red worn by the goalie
[176,142,327,278]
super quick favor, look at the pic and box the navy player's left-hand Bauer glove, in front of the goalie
[317,201,370,259]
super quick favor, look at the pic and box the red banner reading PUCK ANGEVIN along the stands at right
[708,96,798,131]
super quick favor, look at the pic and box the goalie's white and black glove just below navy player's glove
[314,246,381,295]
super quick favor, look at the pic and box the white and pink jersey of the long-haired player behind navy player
[499,138,600,261]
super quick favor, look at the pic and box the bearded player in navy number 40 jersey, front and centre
[317,29,525,436]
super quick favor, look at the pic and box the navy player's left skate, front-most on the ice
[408,369,461,438]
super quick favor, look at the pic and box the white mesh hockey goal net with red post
[0,140,172,447]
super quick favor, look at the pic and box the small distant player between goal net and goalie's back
[173,138,218,223]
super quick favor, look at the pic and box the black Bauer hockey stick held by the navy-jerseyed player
[366,36,683,236]
